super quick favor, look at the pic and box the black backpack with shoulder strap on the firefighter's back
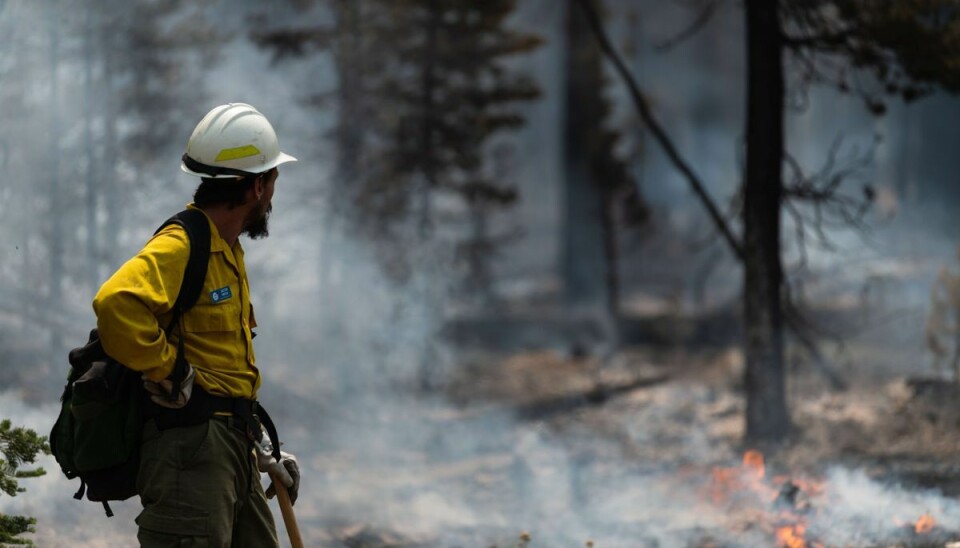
[50,209,210,517]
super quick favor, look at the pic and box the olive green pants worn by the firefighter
[136,419,279,548]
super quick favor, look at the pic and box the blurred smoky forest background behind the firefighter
[0,0,960,546]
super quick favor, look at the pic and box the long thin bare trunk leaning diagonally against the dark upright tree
[577,0,744,262]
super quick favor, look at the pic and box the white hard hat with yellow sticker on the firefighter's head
[180,103,297,179]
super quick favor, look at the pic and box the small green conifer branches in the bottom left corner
[0,419,50,546]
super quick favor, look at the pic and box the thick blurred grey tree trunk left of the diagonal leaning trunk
[560,0,609,317]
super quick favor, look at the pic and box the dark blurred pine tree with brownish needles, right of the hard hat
[255,0,540,286]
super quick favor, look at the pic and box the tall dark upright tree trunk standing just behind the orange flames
[743,0,791,441]
